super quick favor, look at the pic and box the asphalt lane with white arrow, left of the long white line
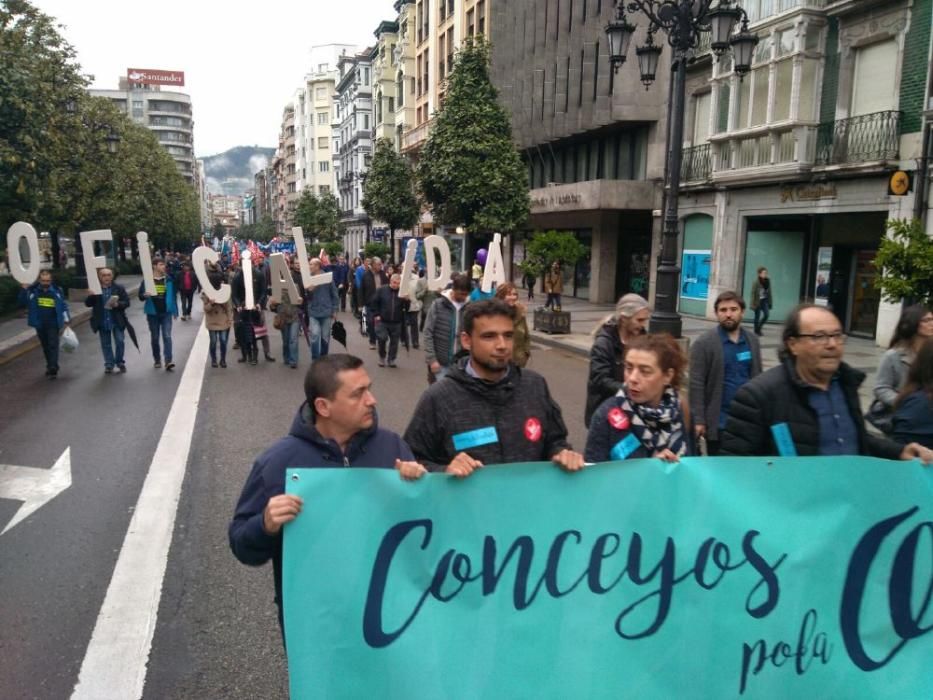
[0,302,205,698]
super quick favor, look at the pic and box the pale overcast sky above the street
[31,0,396,157]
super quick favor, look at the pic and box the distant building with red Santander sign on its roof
[89,69,197,186]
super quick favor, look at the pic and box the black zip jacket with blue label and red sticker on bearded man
[405,357,572,471]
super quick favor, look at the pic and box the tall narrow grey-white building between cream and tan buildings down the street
[333,47,373,258]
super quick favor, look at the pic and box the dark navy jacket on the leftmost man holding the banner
[228,403,414,620]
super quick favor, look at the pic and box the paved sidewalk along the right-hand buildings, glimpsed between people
[523,296,884,410]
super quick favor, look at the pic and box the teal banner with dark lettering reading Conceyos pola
[283,457,933,699]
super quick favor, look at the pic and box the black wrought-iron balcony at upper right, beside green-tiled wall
[816,111,901,165]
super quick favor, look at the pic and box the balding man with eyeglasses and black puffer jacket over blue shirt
[720,304,933,464]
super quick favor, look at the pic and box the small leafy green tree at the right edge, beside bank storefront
[875,219,933,306]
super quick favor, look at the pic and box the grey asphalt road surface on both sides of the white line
[0,303,587,699]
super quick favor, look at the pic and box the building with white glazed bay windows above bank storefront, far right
[680,0,933,344]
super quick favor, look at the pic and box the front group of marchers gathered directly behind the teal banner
[229,278,933,628]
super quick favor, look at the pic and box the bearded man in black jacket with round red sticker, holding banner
[402,299,583,478]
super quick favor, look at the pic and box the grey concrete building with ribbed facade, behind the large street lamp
[491,0,670,302]
